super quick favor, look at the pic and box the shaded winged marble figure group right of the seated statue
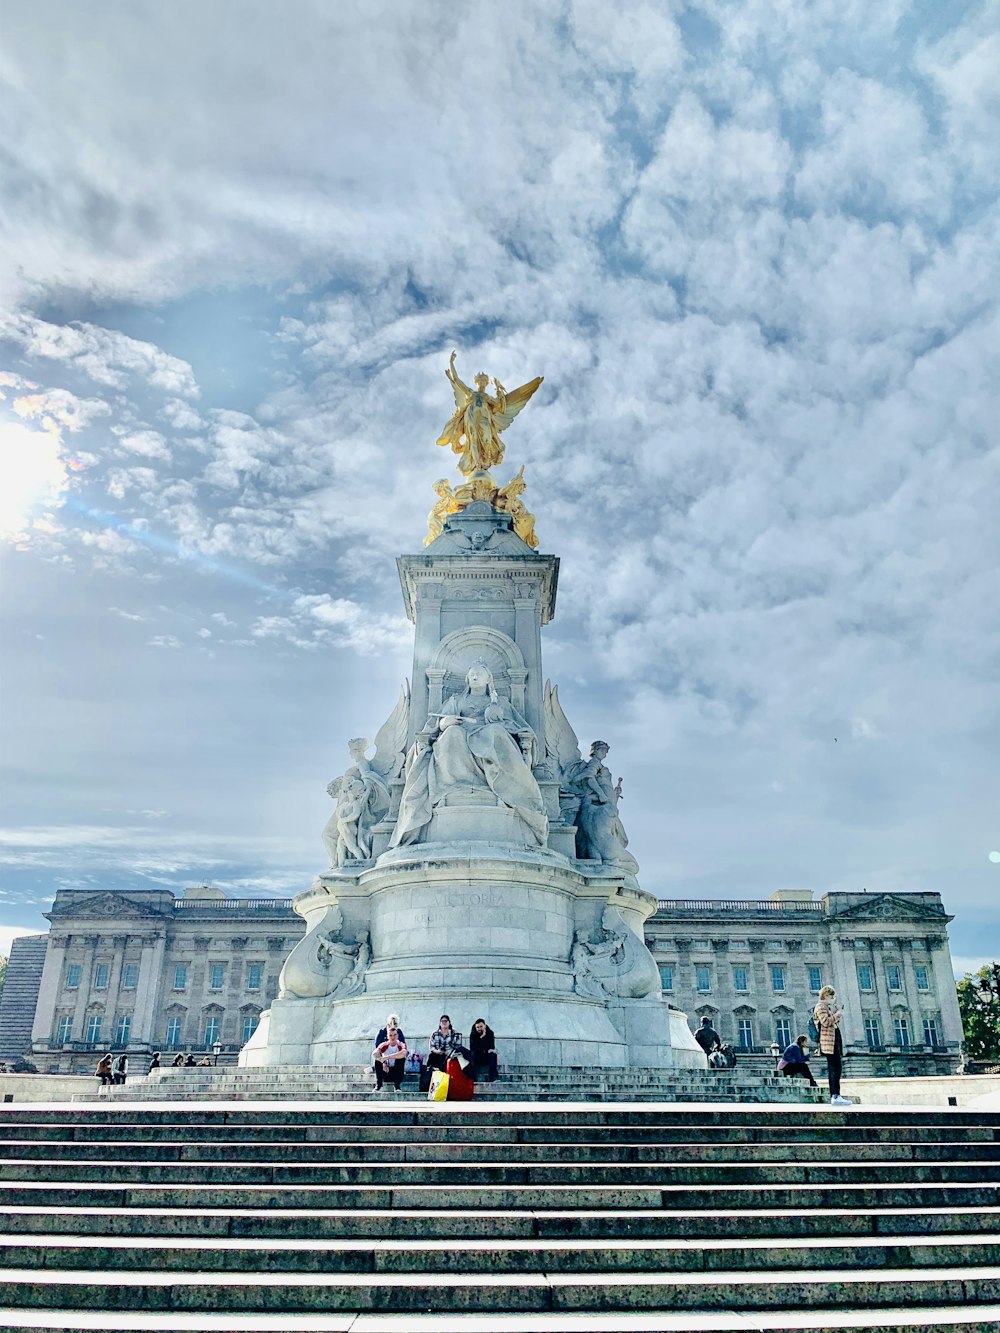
[543,681,639,874]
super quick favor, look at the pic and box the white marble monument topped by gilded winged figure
[240,353,705,1068]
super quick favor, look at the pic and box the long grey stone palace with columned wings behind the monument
[13,886,961,1076]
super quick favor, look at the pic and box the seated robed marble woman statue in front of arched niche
[391,661,548,846]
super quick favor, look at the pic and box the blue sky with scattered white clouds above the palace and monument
[0,0,1000,981]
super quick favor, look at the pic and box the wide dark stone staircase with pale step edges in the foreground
[0,1101,1000,1333]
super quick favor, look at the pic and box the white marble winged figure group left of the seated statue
[323,682,409,866]
